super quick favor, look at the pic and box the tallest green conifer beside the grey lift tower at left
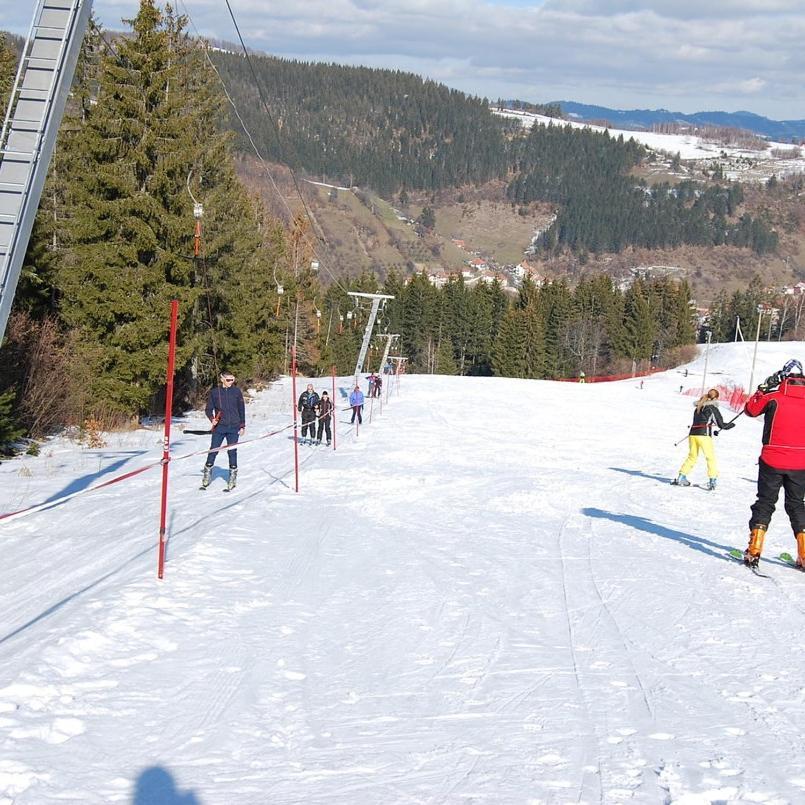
[58,0,278,411]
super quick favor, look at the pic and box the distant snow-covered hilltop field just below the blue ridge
[490,109,805,181]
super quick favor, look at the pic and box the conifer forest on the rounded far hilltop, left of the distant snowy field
[213,52,517,193]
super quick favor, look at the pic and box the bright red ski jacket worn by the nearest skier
[744,377,805,470]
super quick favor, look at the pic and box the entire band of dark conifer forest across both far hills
[214,52,777,254]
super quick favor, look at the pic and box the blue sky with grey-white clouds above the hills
[0,0,805,119]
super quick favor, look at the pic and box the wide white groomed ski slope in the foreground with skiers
[0,343,805,805]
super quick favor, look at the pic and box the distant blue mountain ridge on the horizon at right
[553,101,805,142]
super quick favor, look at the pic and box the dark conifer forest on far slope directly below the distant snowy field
[509,126,777,254]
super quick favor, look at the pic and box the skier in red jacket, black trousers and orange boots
[744,360,805,570]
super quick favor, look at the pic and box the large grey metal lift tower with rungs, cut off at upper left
[0,0,92,340]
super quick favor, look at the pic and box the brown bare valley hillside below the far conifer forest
[238,158,805,305]
